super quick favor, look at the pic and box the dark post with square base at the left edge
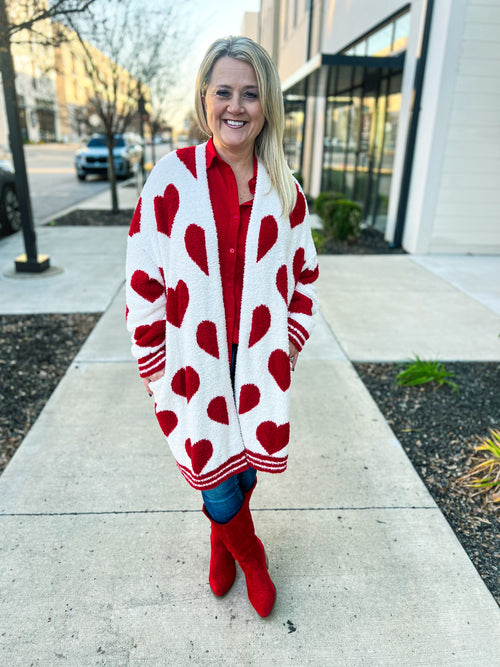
[0,0,50,273]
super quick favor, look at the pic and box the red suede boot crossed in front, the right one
[212,485,276,617]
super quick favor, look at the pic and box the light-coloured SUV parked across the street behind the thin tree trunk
[75,132,144,181]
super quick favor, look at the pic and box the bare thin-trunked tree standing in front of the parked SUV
[66,0,197,211]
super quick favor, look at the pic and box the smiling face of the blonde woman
[203,56,265,158]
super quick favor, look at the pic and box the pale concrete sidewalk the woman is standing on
[0,185,500,667]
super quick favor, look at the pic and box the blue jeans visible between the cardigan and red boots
[201,345,257,523]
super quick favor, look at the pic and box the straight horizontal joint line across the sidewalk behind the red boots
[0,505,439,519]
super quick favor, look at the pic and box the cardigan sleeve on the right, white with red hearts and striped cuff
[288,218,319,352]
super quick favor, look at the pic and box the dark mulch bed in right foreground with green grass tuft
[354,362,500,604]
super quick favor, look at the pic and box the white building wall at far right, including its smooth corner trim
[403,0,500,253]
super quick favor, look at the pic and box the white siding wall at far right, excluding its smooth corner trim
[426,0,500,253]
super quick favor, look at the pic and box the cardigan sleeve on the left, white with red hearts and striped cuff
[126,193,166,378]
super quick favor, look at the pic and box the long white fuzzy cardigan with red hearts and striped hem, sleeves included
[127,144,317,489]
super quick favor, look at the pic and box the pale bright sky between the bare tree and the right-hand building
[169,0,260,132]
